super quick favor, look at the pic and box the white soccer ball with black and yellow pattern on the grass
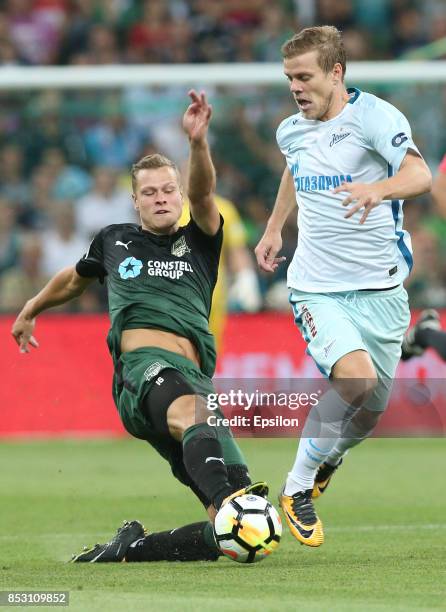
[214,494,282,563]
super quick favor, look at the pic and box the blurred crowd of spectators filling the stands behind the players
[0,0,446,312]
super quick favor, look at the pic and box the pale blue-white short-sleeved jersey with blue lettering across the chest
[277,89,419,292]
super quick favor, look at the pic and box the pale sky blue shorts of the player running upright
[290,285,410,410]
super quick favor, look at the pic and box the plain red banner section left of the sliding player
[0,314,118,436]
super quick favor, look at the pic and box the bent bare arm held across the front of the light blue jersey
[333,151,432,224]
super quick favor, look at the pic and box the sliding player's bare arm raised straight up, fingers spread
[183,89,220,236]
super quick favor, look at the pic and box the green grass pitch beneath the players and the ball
[0,439,446,612]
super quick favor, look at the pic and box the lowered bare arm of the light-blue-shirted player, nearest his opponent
[254,166,296,272]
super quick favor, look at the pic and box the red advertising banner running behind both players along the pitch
[0,311,446,437]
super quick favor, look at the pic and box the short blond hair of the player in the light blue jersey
[281,26,347,79]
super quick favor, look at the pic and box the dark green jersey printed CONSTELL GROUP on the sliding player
[76,219,223,376]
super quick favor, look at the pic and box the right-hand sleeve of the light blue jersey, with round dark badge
[362,94,421,171]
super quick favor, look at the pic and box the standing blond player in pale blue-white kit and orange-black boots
[255,26,432,546]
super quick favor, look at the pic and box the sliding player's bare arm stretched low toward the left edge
[11,267,95,353]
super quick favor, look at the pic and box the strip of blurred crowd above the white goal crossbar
[0,0,446,65]
